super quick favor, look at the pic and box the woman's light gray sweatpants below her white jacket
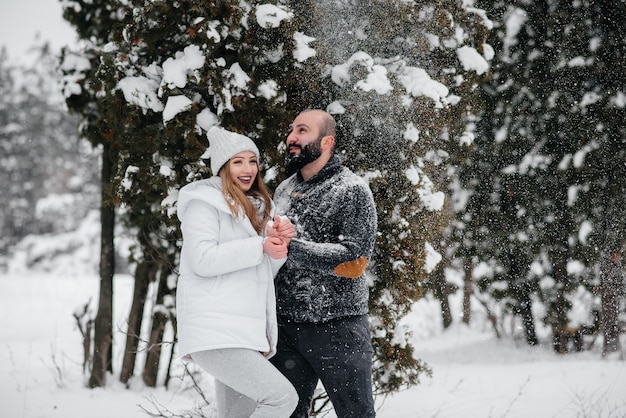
[191,348,298,418]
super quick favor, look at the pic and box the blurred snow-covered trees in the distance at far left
[0,44,97,268]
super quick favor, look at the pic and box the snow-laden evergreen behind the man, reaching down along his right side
[292,0,492,393]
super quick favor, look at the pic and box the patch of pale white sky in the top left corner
[0,0,76,62]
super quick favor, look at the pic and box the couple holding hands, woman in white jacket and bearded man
[177,110,376,418]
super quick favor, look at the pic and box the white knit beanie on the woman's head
[202,126,260,176]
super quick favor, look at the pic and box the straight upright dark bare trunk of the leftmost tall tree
[89,143,115,388]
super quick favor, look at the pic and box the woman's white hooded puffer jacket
[176,176,286,357]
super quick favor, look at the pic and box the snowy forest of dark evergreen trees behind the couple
[0,0,626,417]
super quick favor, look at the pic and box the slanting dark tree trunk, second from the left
[120,261,158,383]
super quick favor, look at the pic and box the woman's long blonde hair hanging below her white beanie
[219,160,272,235]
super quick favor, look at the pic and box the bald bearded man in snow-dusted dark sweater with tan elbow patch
[271,110,377,418]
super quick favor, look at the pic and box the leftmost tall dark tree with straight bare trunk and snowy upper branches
[61,0,123,387]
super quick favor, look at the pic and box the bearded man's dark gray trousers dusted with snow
[270,315,376,418]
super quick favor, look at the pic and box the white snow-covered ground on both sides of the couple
[0,274,626,418]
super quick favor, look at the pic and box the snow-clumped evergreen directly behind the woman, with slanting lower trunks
[60,1,310,385]
